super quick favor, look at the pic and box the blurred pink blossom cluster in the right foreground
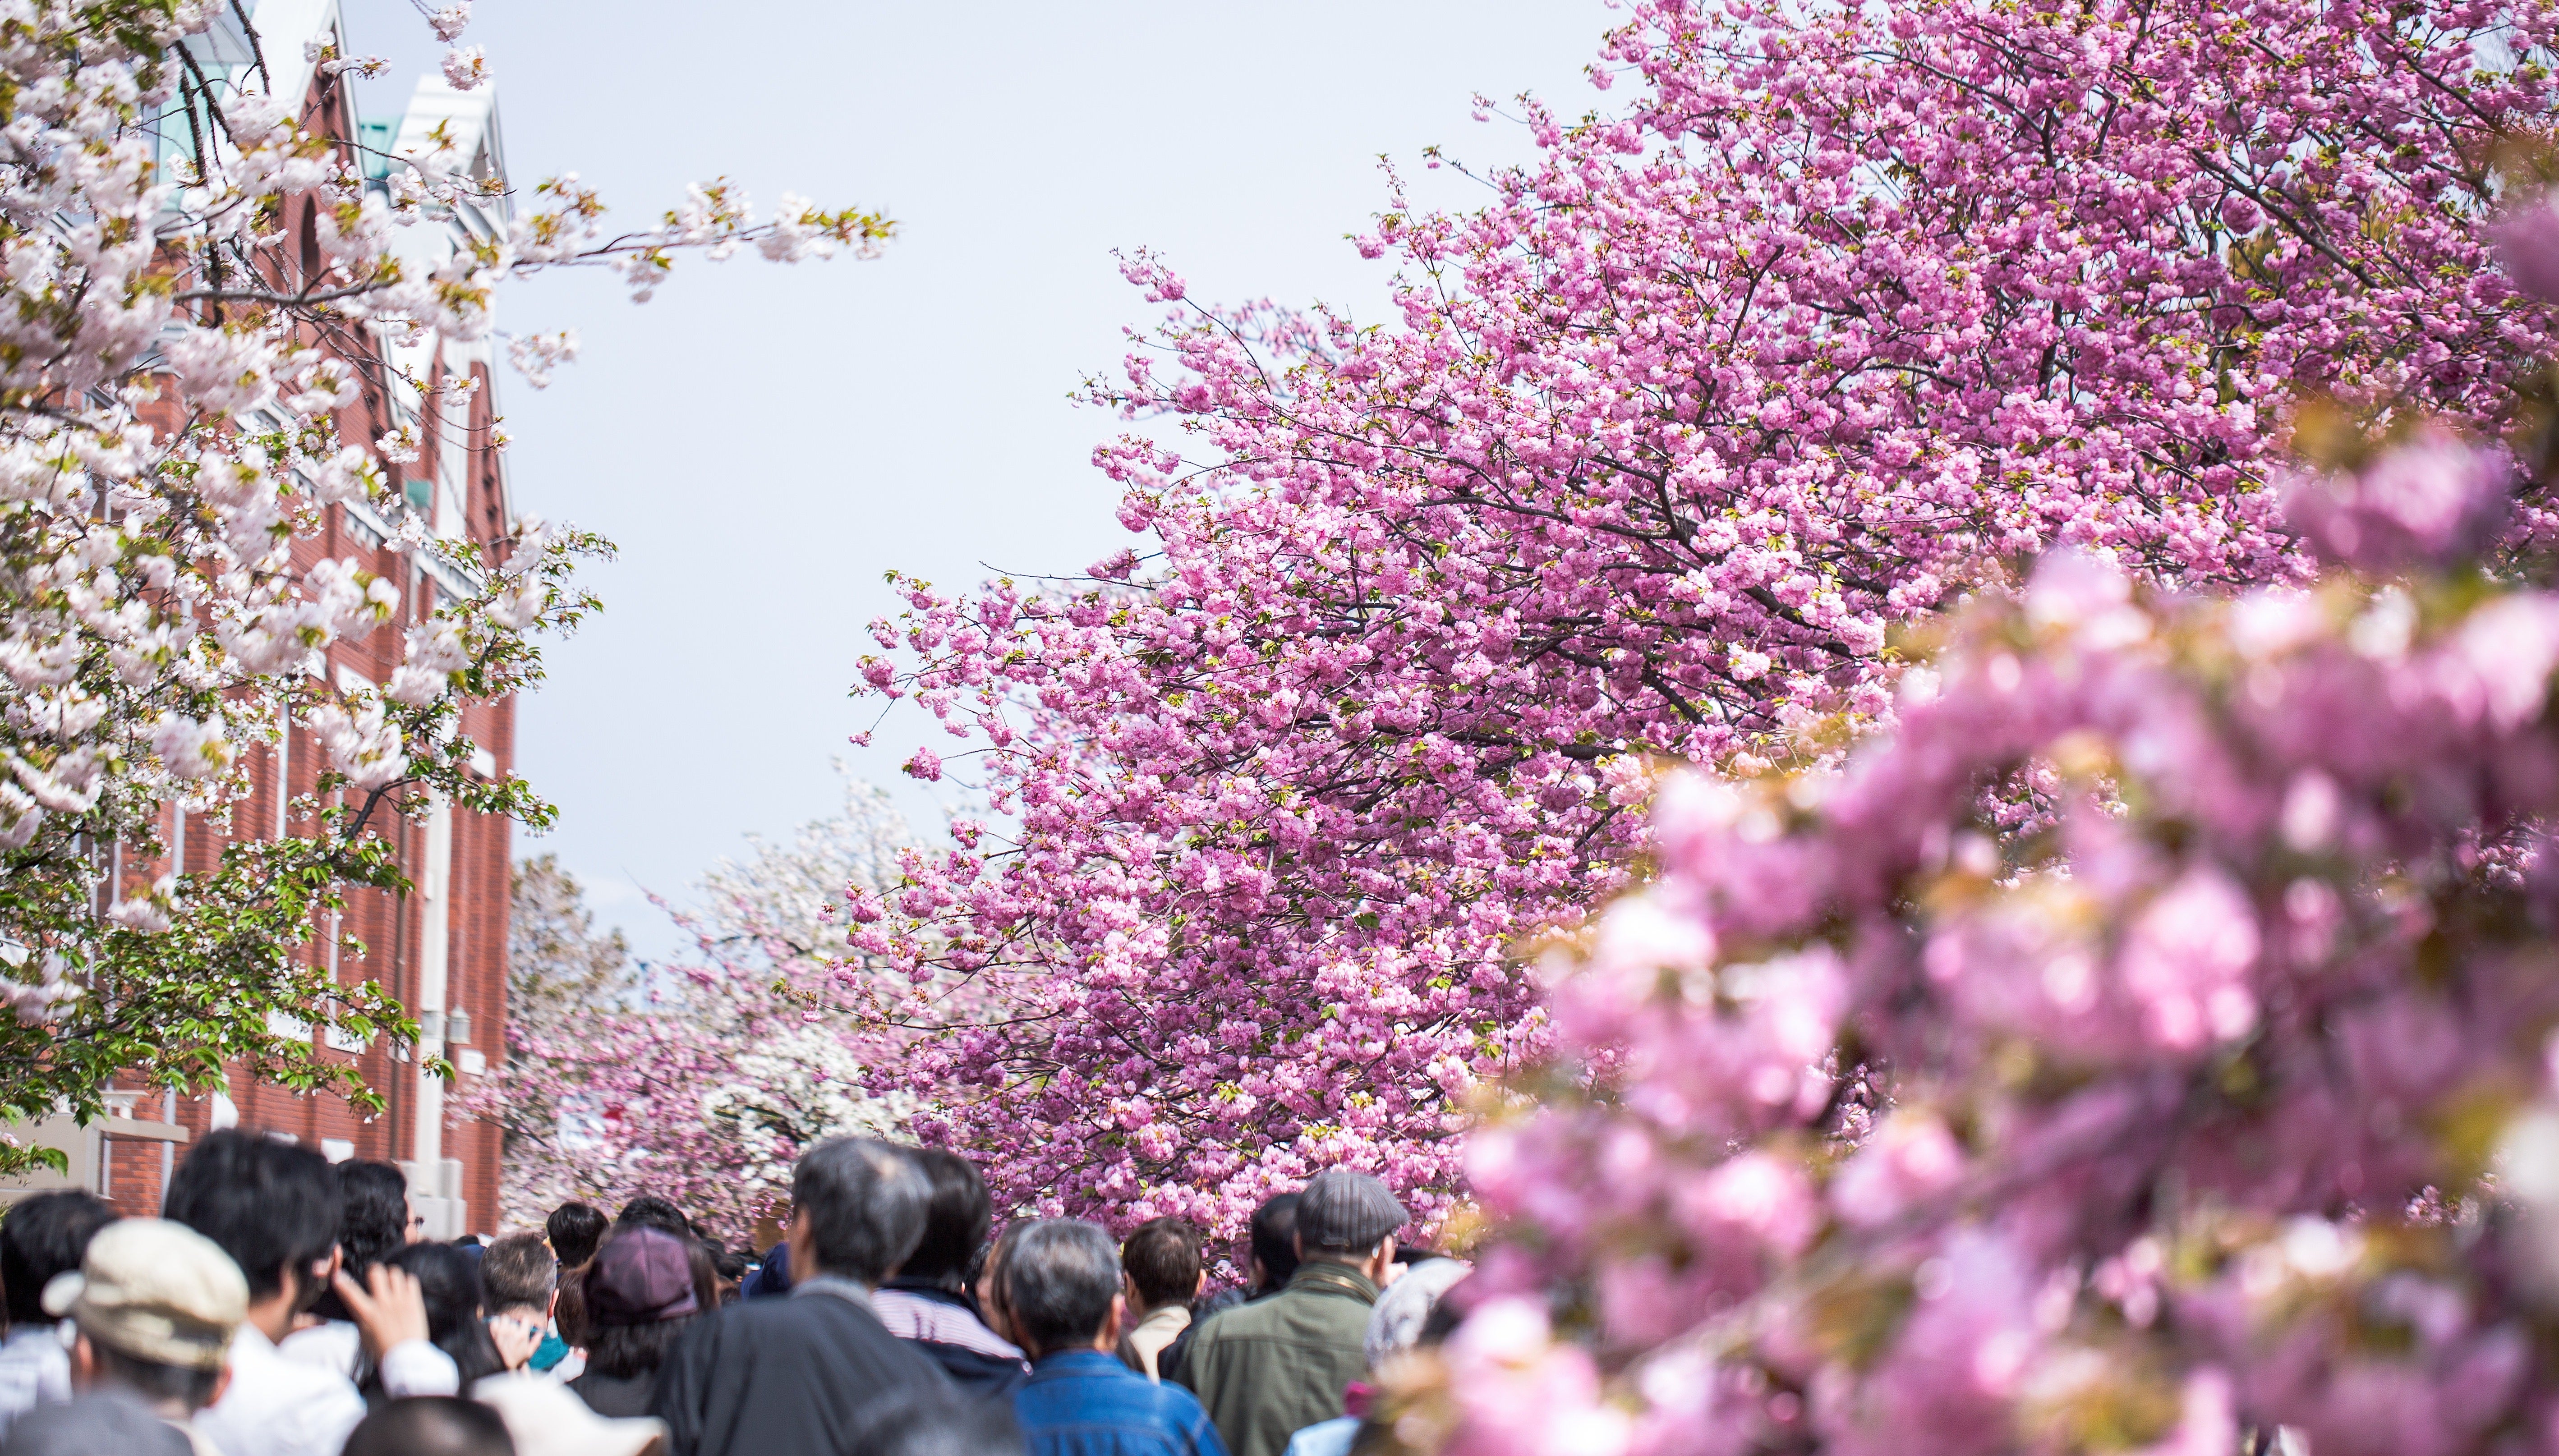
[1397,432,2559,1456]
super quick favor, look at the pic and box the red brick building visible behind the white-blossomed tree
[0,0,514,1239]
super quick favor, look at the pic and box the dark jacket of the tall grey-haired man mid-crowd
[653,1277,957,1456]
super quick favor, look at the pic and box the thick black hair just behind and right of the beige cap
[161,1129,341,1305]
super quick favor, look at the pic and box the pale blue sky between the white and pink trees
[345,0,1622,952]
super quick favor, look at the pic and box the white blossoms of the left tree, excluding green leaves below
[0,0,888,1044]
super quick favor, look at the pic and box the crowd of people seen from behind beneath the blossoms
[0,1131,1466,1456]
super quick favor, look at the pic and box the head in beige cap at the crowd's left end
[43,1218,248,1418]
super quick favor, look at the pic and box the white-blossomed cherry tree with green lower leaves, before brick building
[0,0,891,1169]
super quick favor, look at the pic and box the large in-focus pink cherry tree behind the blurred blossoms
[855,0,2554,1228]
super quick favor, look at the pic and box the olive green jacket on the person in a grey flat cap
[1177,1262,1377,1456]
